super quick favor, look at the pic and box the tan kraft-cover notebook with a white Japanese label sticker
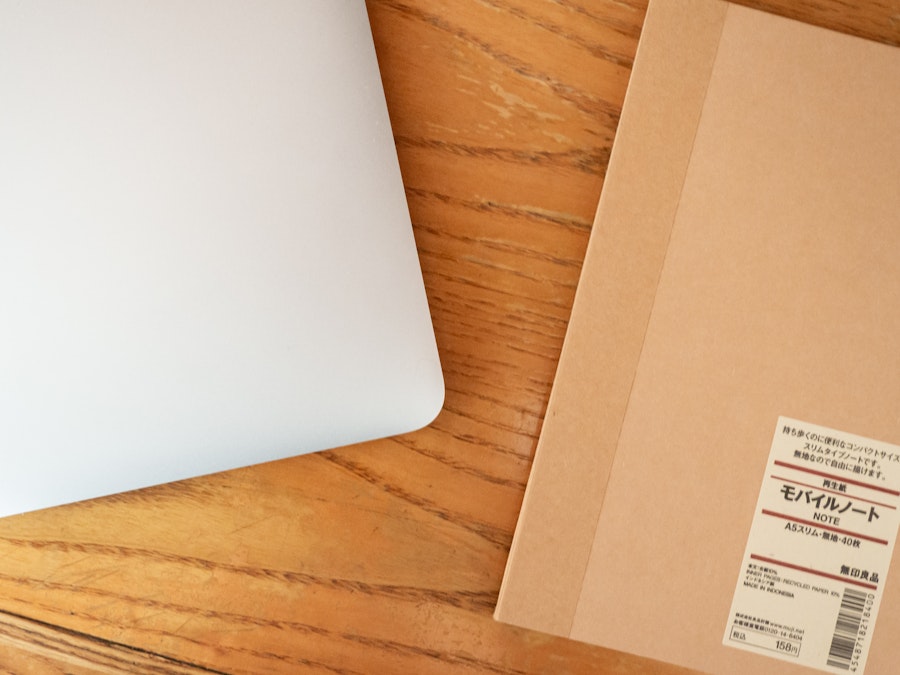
[496,0,900,675]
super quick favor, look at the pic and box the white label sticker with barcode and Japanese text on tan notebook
[723,417,900,675]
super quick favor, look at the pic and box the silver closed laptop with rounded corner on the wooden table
[0,0,444,516]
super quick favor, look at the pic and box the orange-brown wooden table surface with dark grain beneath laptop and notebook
[0,0,900,674]
